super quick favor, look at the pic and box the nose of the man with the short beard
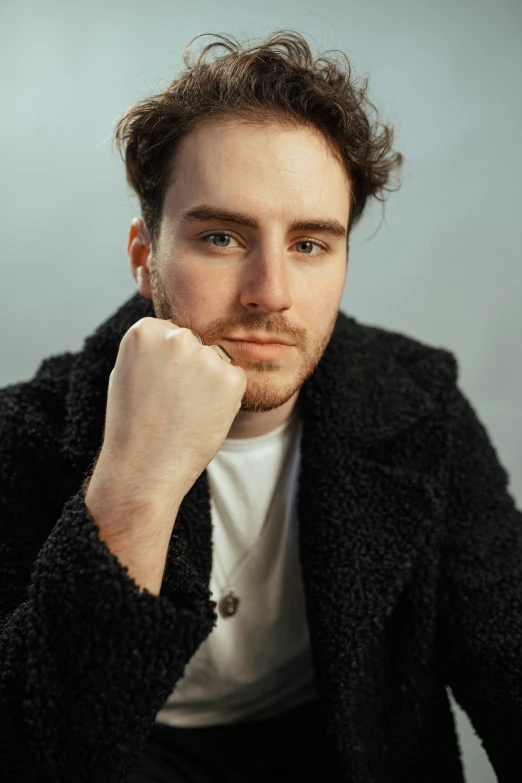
[240,252,292,313]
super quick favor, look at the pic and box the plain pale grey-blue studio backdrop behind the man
[0,0,522,783]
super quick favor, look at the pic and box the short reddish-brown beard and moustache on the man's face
[150,263,338,413]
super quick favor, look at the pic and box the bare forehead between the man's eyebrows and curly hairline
[164,118,350,222]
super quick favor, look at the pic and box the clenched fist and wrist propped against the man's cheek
[89,317,247,520]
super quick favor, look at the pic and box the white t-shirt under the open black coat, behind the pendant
[156,408,316,726]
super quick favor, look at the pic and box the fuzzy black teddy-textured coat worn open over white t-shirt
[0,294,522,783]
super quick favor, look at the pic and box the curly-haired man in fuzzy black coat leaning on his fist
[0,31,522,783]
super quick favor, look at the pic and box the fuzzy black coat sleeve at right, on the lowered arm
[439,386,522,783]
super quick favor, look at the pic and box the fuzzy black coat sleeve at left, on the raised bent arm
[0,386,214,783]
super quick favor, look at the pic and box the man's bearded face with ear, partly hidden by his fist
[129,119,350,412]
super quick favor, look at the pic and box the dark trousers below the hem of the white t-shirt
[125,704,341,783]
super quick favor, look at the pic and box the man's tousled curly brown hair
[115,30,403,247]
